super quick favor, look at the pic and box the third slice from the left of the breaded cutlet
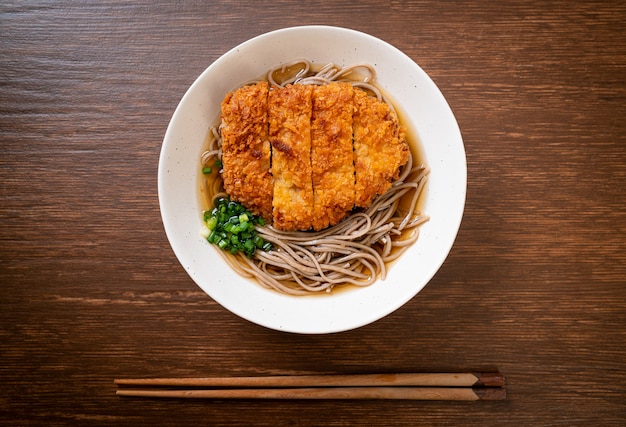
[311,83,354,230]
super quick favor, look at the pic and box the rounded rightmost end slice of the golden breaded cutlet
[352,89,409,208]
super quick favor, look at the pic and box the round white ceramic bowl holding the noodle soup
[158,26,466,334]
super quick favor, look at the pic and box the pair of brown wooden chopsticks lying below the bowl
[114,372,506,401]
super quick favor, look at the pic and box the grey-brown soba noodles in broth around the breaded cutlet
[201,60,429,295]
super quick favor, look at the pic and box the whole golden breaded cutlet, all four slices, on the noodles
[221,82,409,231]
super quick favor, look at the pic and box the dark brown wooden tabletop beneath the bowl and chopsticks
[0,0,626,426]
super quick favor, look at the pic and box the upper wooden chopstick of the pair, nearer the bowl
[115,372,504,388]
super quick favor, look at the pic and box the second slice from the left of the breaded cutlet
[268,85,313,231]
